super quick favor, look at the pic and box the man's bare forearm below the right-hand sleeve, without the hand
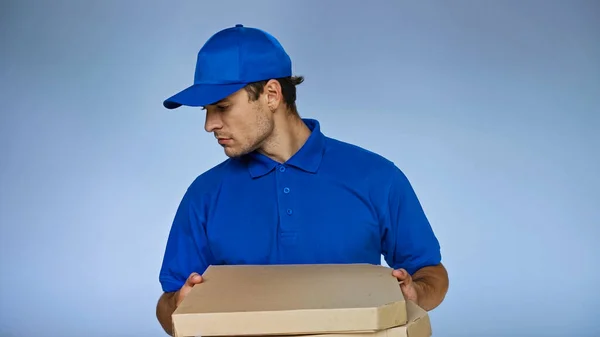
[412,264,449,311]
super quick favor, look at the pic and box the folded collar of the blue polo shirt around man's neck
[248,118,325,178]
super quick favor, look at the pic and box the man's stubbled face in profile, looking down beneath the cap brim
[204,89,274,157]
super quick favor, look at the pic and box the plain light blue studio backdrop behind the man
[0,0,600,337]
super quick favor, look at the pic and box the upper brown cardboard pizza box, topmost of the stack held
[172,264,408,337]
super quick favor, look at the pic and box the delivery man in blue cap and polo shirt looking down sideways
[157,25,448,334]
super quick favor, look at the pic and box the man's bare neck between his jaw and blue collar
[258,112,311,163]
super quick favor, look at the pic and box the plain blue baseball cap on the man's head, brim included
[163,24,292,109]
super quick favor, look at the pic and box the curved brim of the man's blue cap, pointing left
[163,83,246,109]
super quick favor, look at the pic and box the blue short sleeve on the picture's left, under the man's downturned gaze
[159,185,213,292]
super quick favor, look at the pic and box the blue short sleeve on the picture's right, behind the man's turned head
[381,167,441,275]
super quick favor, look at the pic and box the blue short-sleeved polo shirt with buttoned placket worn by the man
[159,119,441,292]
